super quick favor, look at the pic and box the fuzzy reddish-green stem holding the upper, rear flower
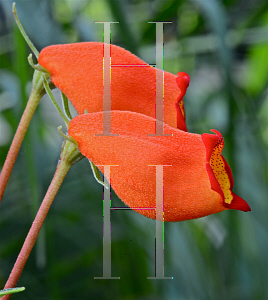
[0,71,45,203]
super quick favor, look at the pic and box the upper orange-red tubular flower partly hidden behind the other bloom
[38,42,190,131]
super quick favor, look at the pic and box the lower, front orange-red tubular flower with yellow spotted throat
[69,111,250,221]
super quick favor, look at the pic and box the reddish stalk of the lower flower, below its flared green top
[1,159,72,300]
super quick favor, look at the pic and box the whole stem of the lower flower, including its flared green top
[1,141,83,300]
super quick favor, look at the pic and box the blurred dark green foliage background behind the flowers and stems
[0,0,268,300]
